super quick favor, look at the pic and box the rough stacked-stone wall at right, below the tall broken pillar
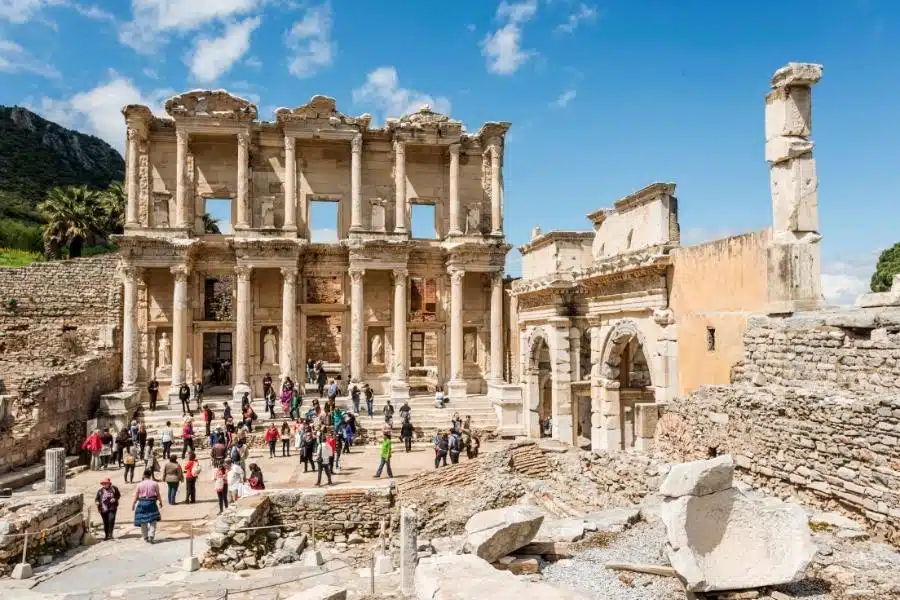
[657,308,900,544]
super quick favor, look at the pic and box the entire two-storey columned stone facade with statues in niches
[118,91,509,397]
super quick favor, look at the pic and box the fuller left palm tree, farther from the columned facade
[38,186,103,258]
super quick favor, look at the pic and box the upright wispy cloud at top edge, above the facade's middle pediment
[285,2,337,78]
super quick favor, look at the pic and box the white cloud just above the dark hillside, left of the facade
[24,72,173,152]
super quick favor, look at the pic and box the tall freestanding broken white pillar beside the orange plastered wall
[766,63,822,313]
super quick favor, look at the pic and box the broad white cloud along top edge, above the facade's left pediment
[119,0,264,54]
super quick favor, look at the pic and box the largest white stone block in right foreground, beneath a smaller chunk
[662,489,816,592]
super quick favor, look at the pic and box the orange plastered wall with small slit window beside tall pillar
[669,230,770,395]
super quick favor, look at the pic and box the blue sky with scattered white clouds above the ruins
[0,0,900,301]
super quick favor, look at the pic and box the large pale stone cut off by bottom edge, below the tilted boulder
[416,554,585,600]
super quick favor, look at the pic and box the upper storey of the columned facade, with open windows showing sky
[122,90,509,241]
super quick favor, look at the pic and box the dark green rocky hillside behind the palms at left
[0,106,125,250]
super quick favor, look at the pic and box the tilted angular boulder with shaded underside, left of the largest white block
[465,506,544,562]
